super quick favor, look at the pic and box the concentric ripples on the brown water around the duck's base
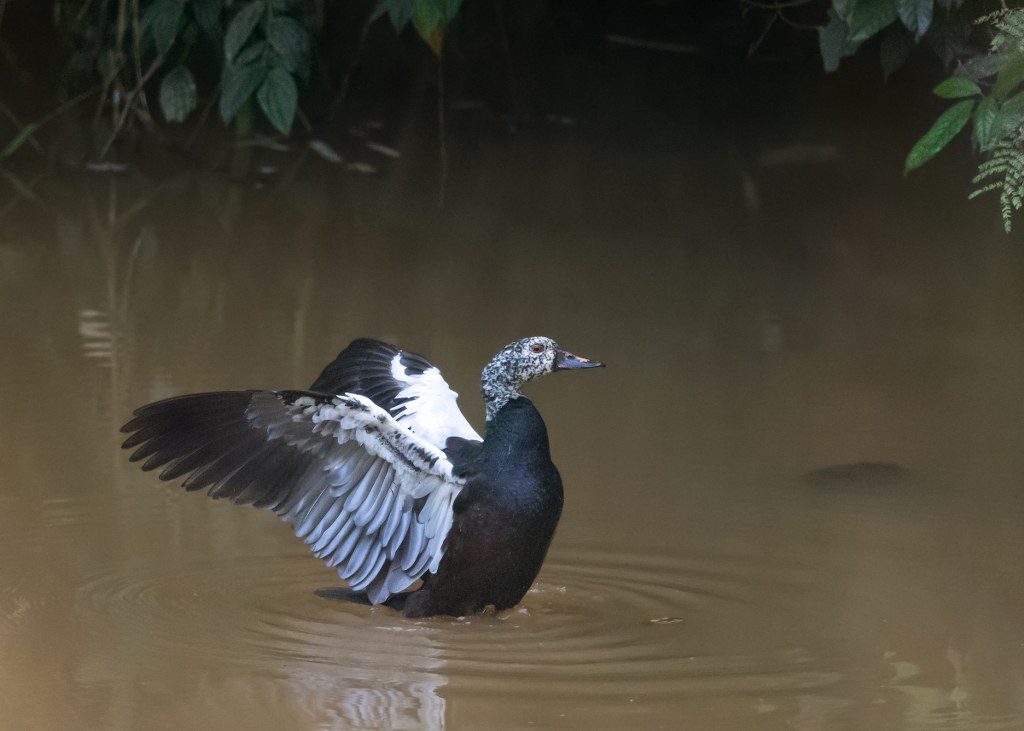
[70,549,841,698]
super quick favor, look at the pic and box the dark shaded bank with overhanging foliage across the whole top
[0,0,1024,231]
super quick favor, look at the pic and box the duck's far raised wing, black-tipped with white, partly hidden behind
[310,338,482,448]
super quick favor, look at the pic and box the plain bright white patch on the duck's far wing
[391,352,483,447]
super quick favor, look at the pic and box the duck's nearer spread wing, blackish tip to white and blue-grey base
[122,391,463,604]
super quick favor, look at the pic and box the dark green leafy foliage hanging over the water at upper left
[0,0,461,160]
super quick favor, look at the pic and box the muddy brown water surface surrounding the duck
[0,54,1024,729]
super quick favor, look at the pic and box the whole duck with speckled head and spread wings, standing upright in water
[122,337,602,616]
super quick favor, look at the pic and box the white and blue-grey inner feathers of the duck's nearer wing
[246,392,464,603]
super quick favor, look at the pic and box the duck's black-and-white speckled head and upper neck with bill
[480,336,604,421]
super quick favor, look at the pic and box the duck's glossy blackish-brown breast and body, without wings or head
[391,397,562,616]
